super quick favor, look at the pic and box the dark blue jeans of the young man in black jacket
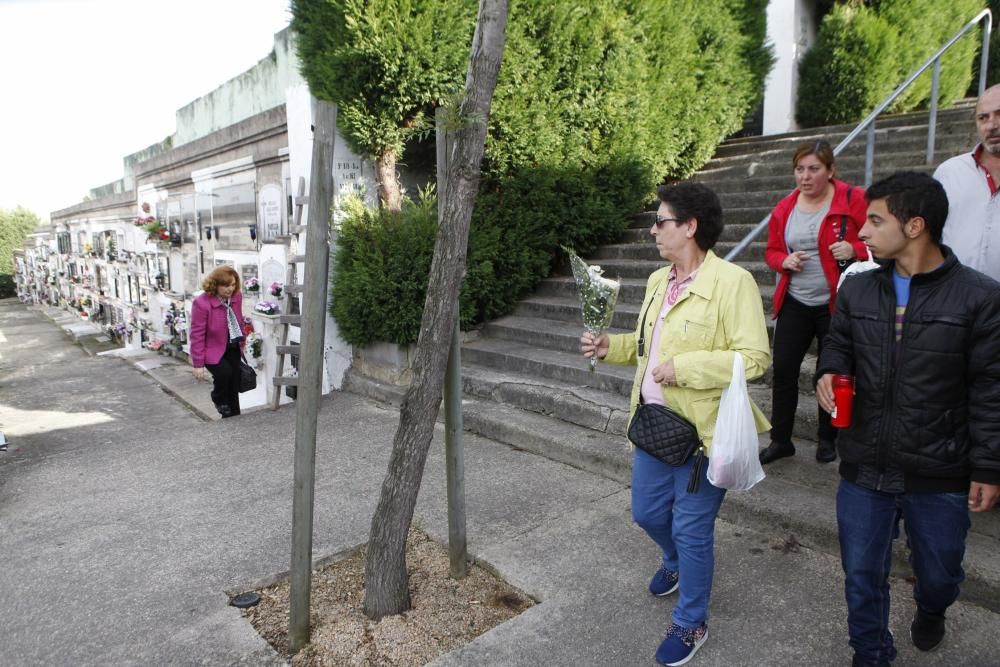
[837,480,971,663]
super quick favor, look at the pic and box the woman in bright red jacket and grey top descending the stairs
[760,141,868,464]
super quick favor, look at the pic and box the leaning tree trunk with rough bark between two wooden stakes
[364,0,507,620]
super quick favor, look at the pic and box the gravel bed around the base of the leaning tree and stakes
[243,530,535,667]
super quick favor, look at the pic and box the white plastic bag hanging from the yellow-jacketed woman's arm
[708,352,764,491]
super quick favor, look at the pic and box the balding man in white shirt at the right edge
[934,85,1000,280]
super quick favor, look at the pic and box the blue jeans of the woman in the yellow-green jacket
[632,448,726,628]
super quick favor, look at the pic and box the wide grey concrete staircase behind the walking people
[346,103,1000,611]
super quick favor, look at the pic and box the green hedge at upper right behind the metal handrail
[796,0,981,127]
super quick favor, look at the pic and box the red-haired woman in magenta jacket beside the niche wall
[191,266,245,419]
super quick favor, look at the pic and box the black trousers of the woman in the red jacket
[771,294,837,444]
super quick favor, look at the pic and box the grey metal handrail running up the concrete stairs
[725,9,993,262]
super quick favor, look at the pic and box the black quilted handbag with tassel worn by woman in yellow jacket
[628,403,705,493]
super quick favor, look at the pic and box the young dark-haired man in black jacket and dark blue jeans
[816,173,1000,665]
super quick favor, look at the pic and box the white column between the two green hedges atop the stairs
[763,0,816,135]
